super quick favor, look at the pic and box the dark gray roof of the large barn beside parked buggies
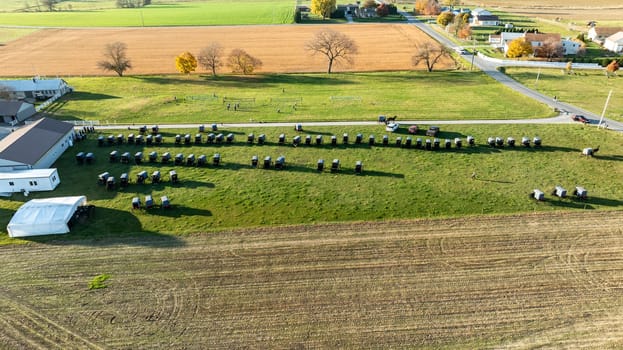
[0,118,74,165]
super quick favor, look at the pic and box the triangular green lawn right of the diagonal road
[506,68,623,121]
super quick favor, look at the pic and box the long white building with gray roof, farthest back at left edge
[0,78,73,100]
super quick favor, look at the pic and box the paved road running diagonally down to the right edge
[401,12,623,132]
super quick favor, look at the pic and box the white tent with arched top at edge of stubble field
[7,196,87,237]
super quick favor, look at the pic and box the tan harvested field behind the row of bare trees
[0,24,454,76]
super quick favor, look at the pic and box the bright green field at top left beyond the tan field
[0,0,294,27]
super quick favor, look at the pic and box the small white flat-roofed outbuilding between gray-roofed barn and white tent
[0,169,61,193]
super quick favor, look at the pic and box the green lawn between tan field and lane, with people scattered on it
[46,71,551,123]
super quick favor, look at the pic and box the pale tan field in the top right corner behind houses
[464,0,623,24]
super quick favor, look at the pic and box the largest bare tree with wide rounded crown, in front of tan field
[305,29,358,74]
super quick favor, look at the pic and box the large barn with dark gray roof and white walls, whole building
[0,118,74,172]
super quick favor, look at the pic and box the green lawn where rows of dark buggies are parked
[0,124,623,243]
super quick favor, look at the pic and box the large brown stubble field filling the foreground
[0,211,623,349]
